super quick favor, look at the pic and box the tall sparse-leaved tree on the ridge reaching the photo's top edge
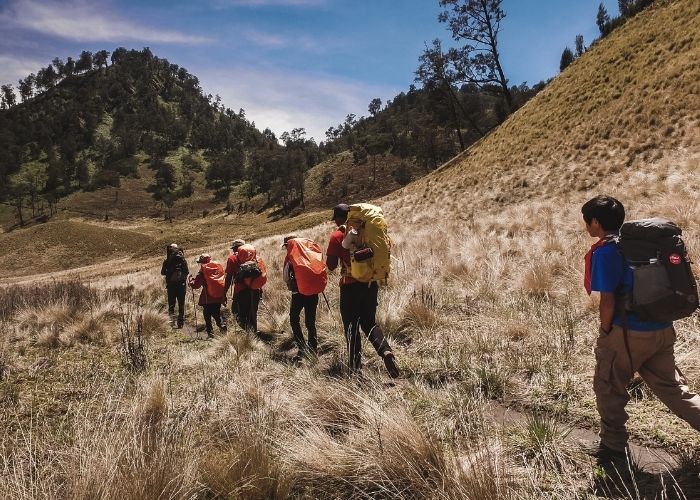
[438,0,513,111]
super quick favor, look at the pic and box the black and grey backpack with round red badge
[616,218,698,322]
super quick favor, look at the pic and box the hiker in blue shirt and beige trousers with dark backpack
[581,196,700,465]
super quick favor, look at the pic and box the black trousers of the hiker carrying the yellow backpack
[340,282,391,370]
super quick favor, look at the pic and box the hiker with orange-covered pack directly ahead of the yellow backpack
[282,234,328,356]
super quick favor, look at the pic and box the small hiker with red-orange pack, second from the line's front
[188,253,226,338]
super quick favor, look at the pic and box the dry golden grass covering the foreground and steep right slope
[0,0,700,500]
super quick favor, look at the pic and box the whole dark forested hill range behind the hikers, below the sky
[0,44,543,225]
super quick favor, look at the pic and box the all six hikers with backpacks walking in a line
[162,195,700,442]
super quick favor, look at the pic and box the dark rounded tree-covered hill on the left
[0,48,288,225]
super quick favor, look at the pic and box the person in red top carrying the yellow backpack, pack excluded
[326,203,399,378]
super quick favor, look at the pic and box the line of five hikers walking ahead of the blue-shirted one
[161,203,400,378]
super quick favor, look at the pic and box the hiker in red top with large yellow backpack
[326,203,399,378]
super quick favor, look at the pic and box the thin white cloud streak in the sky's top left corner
[0,0,210,45]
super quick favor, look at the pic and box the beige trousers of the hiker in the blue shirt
[593,326,700,451]
